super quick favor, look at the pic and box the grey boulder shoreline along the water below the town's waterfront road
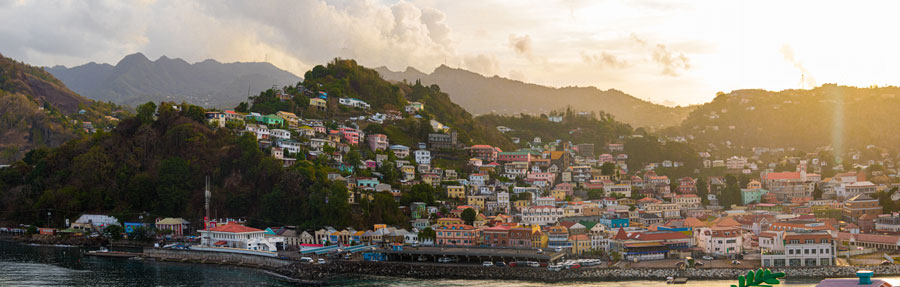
[275,261,900,283]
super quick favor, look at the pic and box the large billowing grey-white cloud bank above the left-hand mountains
[0,0,458,77]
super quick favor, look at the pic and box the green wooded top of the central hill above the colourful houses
[302,59,512,151]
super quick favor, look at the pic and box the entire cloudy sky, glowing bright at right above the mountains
[0,0,900,106]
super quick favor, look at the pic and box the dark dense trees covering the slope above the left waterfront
[0,103,392,231]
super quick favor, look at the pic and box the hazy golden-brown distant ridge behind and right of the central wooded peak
[375,65,693,128]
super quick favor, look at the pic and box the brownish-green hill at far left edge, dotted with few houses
[0,55,118,164]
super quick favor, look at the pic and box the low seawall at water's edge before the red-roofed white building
[143,248,292,270]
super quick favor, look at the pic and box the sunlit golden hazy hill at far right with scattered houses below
[679,84,900,154]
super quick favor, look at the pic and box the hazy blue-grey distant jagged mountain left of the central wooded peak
[46,53,300,107]
